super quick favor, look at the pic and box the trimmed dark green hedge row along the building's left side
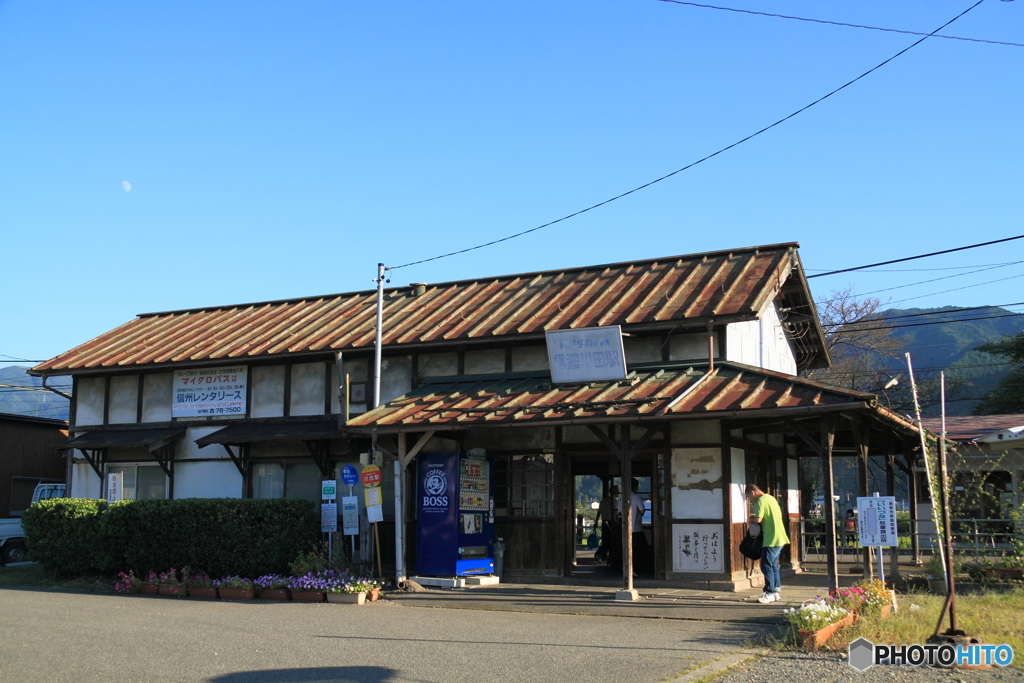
[22,498,319,577]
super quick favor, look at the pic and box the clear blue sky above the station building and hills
[0,0,1024,368]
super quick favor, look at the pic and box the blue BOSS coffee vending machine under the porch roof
[416,453,495,577]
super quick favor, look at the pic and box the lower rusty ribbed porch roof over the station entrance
[346,362,874,432]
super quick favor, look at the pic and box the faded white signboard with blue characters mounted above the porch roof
[545,325,626,384]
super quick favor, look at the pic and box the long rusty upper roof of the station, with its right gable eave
[31,244,828,375]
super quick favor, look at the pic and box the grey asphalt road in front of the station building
[0,589,772,683]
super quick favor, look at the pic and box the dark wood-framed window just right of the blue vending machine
[493,453,555,517]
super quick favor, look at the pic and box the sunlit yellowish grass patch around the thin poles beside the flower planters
[798,588,1024,669]
